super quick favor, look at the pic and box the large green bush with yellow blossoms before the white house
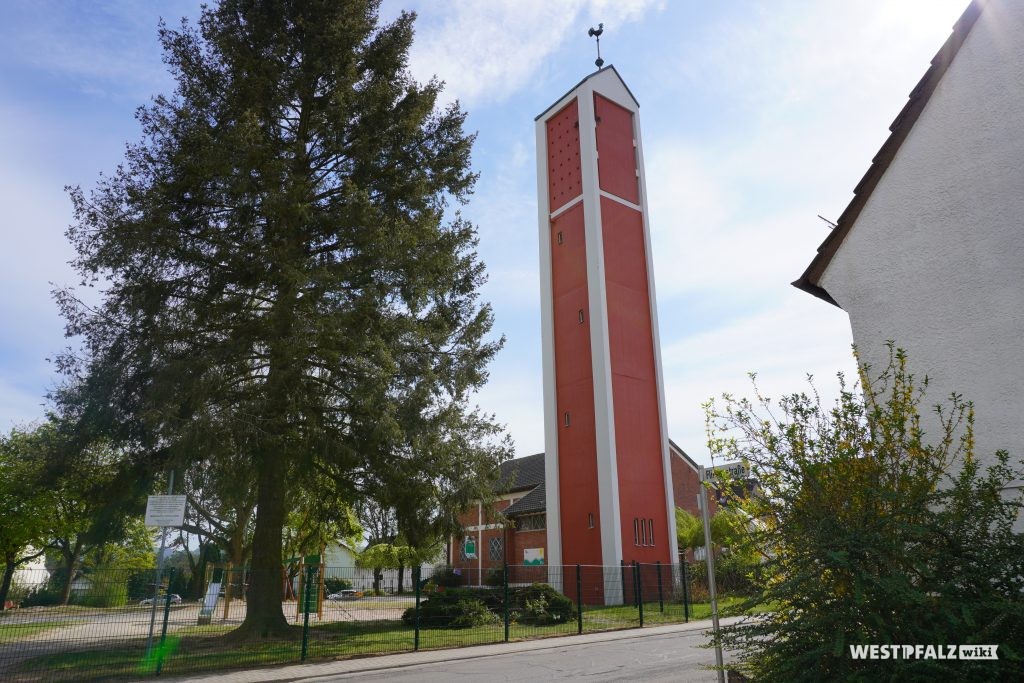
[708,345,1024,681]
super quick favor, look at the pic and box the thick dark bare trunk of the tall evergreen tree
[232,449,289,639]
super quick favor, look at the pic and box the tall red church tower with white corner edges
[537,66,678,602]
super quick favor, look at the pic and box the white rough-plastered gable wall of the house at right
[821,0,1024,518]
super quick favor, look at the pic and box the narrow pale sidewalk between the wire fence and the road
[167,616,741,683]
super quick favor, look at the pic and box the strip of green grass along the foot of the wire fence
[12,598,765,681]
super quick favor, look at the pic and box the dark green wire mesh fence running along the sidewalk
[0,564,737,681]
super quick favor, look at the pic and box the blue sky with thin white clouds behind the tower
[0,0,967,463]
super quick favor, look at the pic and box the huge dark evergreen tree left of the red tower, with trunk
[58,0,504,636]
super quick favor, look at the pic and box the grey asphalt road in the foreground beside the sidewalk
[293,631,718,683]
